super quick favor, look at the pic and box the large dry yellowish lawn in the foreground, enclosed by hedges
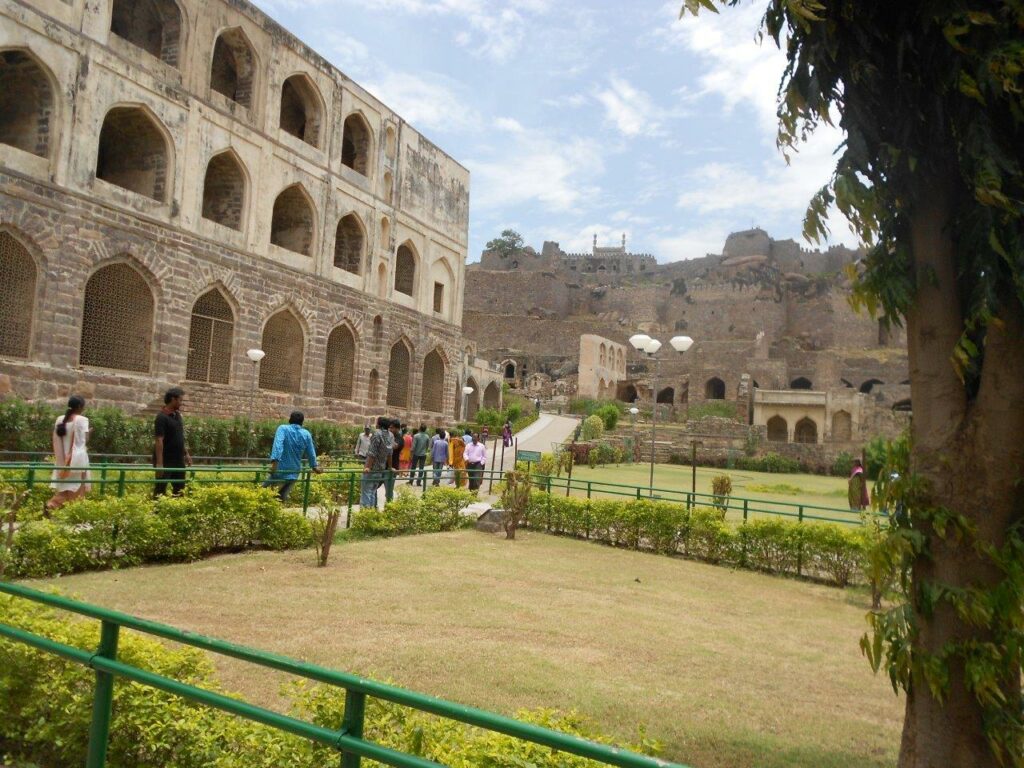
[36,531,901,768]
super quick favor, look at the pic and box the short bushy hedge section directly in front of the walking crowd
[351,487,477,538]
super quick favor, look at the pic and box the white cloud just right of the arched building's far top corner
[467,130,604,213]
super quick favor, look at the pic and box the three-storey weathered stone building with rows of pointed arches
[0,0,501,421]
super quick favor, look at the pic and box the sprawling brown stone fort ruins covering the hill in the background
[465,228,910,466]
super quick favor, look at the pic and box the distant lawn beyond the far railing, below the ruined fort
[562,464,856,520]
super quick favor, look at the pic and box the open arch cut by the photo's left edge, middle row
[0,50,53,158]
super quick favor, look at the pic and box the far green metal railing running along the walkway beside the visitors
[0,462,861,525]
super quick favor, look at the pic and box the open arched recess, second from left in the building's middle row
[96,106,170,203]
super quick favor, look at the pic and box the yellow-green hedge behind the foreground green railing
[0,596,658,768]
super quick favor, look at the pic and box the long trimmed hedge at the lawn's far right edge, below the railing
[527,492,868,587]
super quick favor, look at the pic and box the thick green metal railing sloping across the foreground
[0,582,685,768]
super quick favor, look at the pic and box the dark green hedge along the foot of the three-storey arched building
[0,398,361,456]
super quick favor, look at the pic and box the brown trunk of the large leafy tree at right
[899,181,1024,768]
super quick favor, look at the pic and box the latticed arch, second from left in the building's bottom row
[79,263,155,372]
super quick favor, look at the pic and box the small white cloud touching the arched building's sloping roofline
[365,71,481,133]
